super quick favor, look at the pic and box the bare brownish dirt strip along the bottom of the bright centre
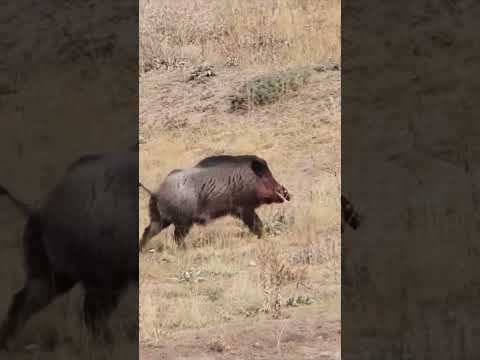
[140,309,340,360]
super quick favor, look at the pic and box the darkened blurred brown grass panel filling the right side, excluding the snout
[342,1,480,359]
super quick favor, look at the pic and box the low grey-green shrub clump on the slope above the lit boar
[230,69,310,111]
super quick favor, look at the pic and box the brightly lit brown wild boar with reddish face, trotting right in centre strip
[140,155,290,250]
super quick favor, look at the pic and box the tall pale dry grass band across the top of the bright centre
[140,0,340,72]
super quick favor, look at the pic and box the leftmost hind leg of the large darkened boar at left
[0,277,75,348]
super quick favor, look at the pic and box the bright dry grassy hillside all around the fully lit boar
[139,0,341,359]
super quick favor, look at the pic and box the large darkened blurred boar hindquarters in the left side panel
[0,151,138,348]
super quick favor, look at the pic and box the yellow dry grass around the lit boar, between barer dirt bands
[139,71,340,346]
